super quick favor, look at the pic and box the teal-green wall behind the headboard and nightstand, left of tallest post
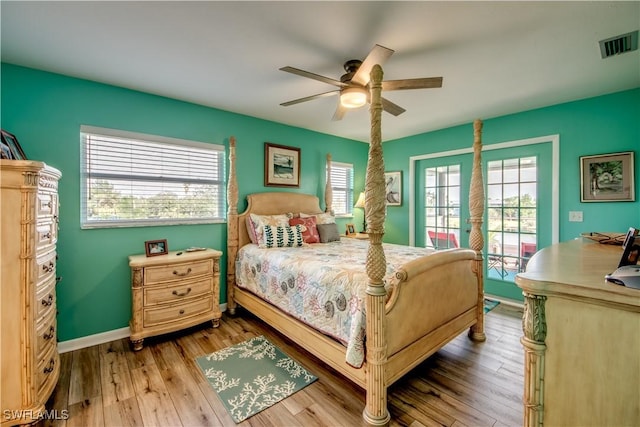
[1,64,368,341]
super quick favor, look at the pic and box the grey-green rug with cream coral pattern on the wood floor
[196,336,317,423]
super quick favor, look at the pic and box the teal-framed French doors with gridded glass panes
[415,143,553,300]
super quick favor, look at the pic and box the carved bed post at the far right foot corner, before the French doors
[469,119,487,341]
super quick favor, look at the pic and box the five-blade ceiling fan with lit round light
[280,44,442,120]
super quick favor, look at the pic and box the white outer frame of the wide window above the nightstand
[80,125,226,229]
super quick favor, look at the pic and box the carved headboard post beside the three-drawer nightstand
[227,136,239,315]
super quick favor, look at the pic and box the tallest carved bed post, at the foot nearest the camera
[362,65,390,425]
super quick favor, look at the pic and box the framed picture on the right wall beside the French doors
[580,151,635,202]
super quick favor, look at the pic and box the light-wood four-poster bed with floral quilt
[227,66,485,425]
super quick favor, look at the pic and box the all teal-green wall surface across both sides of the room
[1,64,640,341]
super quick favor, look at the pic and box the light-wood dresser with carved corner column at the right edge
[516,240,640,427]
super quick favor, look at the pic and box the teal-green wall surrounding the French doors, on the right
[384,88,640,244]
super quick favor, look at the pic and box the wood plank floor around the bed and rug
[39,304,524,427]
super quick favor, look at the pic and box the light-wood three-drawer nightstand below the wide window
[129,249,222,351]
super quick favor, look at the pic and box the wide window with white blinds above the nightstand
[80,126,225,228]
